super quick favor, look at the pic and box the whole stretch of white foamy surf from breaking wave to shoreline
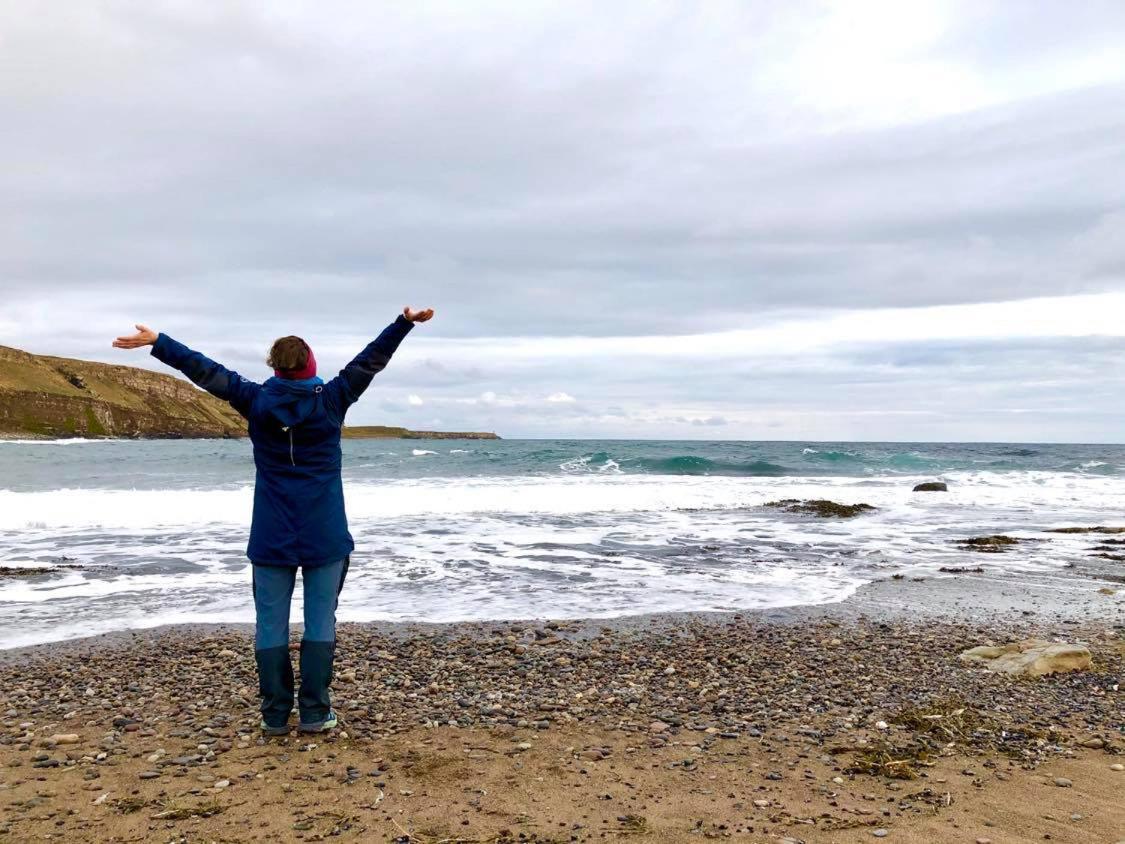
[0,470,1125,647]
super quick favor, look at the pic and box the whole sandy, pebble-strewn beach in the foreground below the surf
[0,574,1125,844]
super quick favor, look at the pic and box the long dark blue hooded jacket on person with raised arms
[152,316,414,566]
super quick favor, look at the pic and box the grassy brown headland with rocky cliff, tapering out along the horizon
[0,345,500,440]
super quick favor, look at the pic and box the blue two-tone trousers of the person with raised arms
[252,557,349,727]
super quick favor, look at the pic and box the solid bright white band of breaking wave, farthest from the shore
[0,470,1125,530]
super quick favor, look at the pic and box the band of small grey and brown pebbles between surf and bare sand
[0,620,1125,841]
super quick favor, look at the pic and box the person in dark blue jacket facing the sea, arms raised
[114,307,433,735]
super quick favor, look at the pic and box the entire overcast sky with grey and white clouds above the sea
[0,0,1125,442]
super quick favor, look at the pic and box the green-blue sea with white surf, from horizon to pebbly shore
[0,440,1125,648]
